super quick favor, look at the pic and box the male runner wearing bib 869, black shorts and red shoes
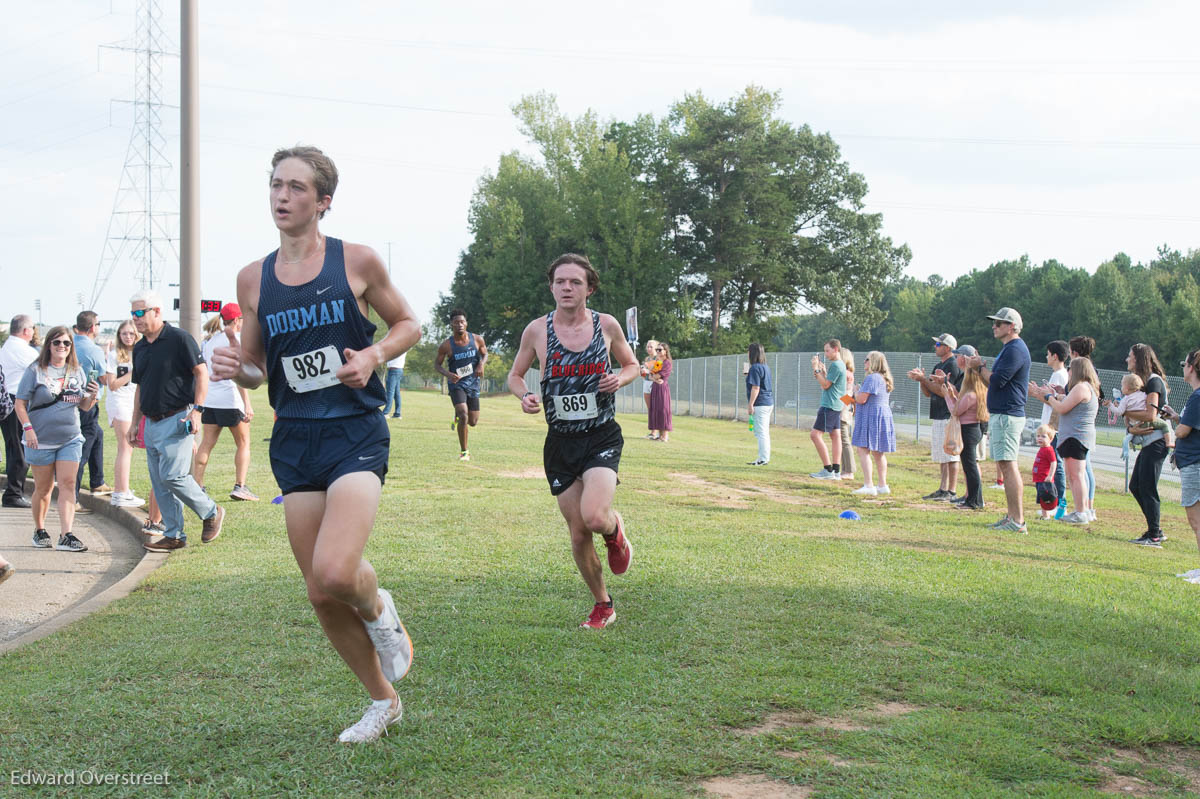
[509,253,638,629]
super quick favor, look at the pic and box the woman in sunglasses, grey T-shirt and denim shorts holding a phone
[14,325,100,552]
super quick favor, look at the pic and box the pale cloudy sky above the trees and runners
[0,0,1200,323]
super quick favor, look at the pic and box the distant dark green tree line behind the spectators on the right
[773,247,1200,373]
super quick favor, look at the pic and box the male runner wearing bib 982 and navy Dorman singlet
[212,146,421,743]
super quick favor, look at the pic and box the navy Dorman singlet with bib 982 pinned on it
[258,236,384,419]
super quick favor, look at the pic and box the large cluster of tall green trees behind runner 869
[434,86,911,355]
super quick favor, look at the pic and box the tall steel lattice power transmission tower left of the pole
[89,0,179,308]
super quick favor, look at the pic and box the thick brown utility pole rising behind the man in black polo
[179,0,200,341]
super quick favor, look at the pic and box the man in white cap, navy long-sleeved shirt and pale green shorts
[970,307,1032,533]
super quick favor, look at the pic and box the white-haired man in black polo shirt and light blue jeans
[130,292,224,552]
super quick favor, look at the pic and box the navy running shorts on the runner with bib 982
[271,411,391,494]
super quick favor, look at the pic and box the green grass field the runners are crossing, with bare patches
[0,391,1200,797]
